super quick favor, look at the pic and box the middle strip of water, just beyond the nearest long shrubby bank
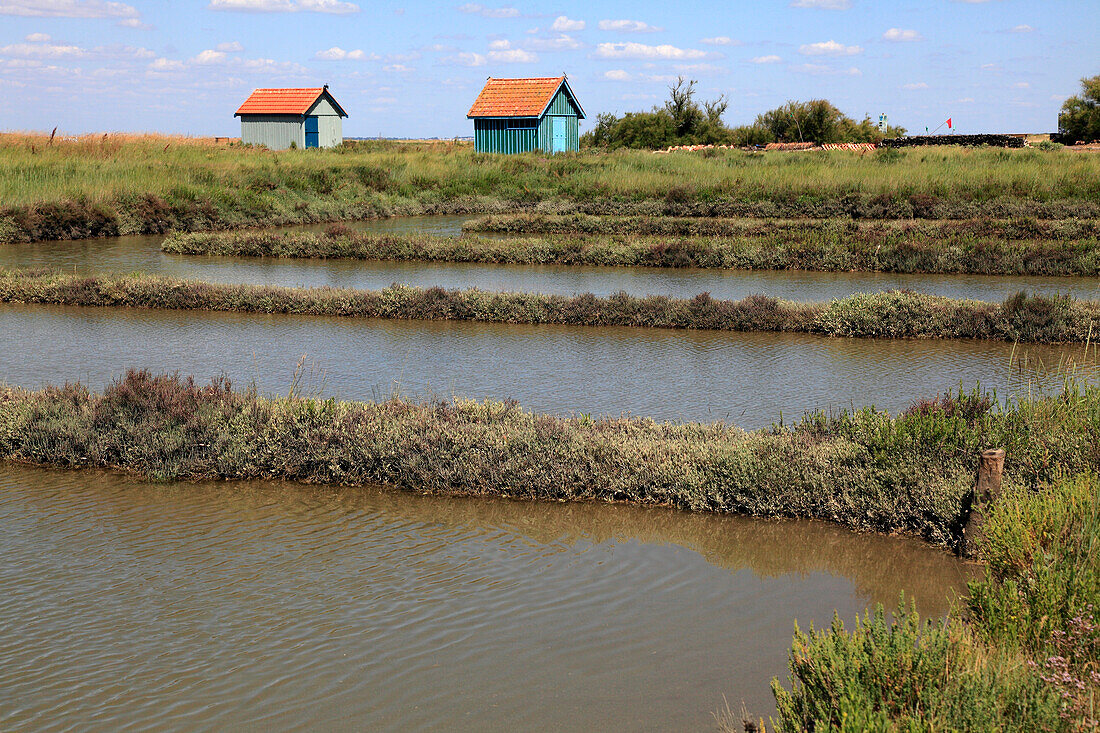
[0,305,1100,428]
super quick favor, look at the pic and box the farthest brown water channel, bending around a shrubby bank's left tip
[0,217,1100,302]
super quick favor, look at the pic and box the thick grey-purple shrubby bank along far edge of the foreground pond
[0,372,1100,545]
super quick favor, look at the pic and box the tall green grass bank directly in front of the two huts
[0,134,1100,242]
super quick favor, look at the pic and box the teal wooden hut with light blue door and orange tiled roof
[466,76,584,153]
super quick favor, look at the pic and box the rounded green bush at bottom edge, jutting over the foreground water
[772,604,1063,733]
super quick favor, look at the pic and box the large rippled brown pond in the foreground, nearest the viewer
[0,464,968,731]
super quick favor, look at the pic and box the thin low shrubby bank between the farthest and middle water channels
[0,271,1100,342]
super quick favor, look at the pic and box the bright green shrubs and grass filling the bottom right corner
[756,467,1100,733]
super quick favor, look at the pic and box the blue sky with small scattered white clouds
[0,0,1100,136]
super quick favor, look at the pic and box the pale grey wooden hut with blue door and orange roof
[233,85,348,150]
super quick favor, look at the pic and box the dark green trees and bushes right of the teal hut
[581,77,905,150]
